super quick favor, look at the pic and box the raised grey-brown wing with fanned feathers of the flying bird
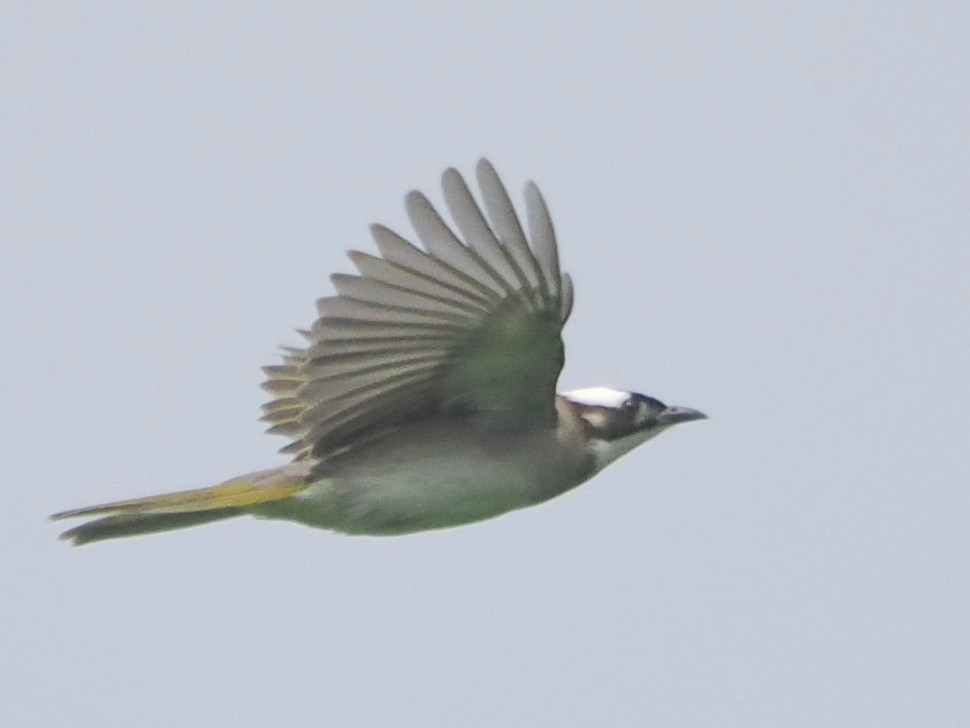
[263,159,572,458]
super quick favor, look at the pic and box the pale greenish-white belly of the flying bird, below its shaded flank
[257,426,577,535]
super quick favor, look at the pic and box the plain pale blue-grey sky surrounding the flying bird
[0,2,970,728]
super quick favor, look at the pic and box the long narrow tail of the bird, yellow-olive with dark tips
[51,462,309,546]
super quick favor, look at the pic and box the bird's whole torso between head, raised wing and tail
[255,402,593,535]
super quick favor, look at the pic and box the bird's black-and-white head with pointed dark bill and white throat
[562,387,707,472]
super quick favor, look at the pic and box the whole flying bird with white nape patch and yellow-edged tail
[51,159,706,545]
